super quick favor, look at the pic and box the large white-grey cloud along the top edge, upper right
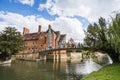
[38,0,120,21]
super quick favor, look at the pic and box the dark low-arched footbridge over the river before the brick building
[39,48,81,54]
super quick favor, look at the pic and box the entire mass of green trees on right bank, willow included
[84,14,120,61]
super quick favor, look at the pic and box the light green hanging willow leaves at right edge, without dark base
[108,14,120,53]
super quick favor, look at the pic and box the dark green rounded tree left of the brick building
[0,27,24,58]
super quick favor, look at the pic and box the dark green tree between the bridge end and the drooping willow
[84,17,107,49]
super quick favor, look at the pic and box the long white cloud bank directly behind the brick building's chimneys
[0,11,85,42]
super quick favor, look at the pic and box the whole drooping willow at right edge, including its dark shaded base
[107,14,120,62]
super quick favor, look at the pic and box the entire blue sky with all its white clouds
[0,0,120,42]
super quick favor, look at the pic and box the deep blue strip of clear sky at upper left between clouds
[0,0,55,20]
